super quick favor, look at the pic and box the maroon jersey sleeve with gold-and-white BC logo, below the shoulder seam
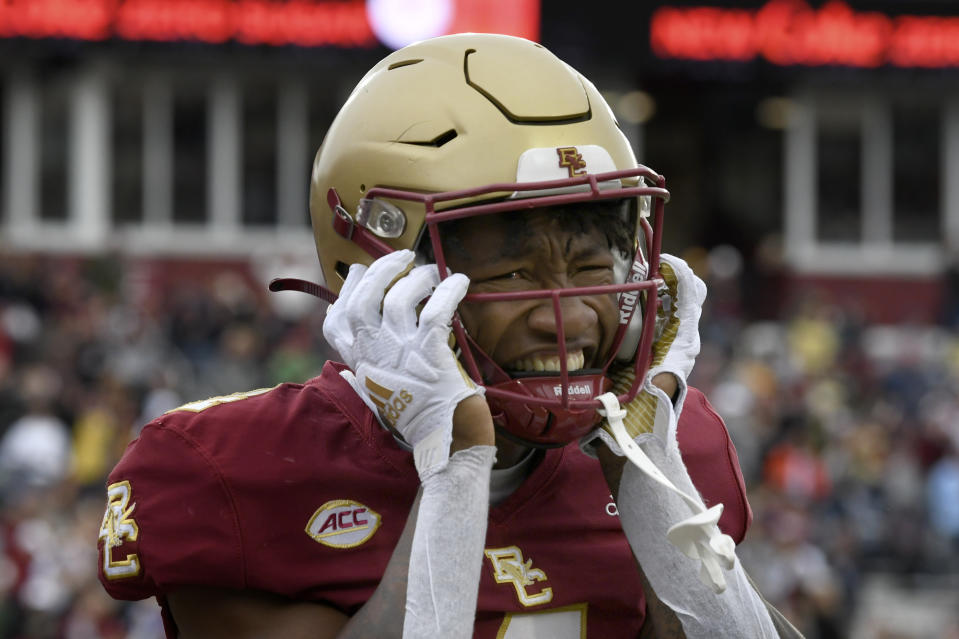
[97,414,245,599]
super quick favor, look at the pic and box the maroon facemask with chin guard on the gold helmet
[270,166,669,447]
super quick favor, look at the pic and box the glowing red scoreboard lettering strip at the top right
[649,0,959,68]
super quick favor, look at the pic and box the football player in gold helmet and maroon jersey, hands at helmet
[99,34,804,639]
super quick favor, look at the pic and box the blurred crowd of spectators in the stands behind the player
[0,248,959,639]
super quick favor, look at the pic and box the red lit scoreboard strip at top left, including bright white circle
[0,0,539,47]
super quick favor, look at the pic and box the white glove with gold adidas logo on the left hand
[323,251,483,478]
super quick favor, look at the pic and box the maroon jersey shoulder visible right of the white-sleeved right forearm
[676,387,753,544]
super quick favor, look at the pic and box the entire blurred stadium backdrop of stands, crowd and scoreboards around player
[0,0,959,638]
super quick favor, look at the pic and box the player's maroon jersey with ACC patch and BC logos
[98,363,751,639]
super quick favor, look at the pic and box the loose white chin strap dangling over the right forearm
[596,393,736,593]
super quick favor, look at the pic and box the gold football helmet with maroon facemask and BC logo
[288,34,669,446]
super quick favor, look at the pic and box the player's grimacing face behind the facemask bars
[445,211,619,374]
